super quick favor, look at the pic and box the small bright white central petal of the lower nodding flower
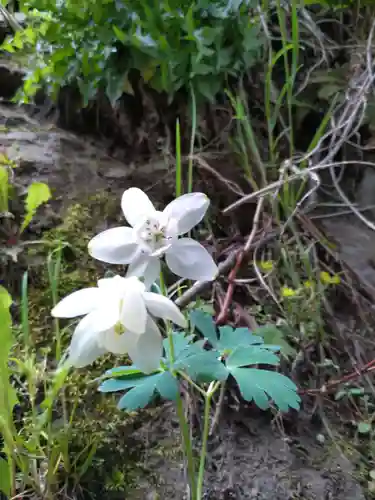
[120,286,147,333]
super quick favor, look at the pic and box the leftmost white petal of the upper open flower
[88,227,138,264]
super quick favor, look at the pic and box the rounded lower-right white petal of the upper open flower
[166,238,218,281]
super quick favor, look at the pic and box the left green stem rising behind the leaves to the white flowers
[160,272,197,500]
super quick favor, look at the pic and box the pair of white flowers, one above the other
[52,188,218,373]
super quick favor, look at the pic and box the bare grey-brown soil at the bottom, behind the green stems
[116,405,365,500]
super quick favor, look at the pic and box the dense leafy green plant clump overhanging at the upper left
[3,0,263,105]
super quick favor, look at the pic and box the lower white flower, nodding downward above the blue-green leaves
[52,276,186,373]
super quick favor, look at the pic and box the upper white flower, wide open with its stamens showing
[89,188,218,287]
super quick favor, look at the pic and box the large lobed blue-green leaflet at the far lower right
[230,368,301,412]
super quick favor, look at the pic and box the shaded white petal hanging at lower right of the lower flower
[128,317,163,373]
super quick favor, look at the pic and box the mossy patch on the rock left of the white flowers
[28,192,118,345]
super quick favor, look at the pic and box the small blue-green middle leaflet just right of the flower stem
[174,351,229,381]
